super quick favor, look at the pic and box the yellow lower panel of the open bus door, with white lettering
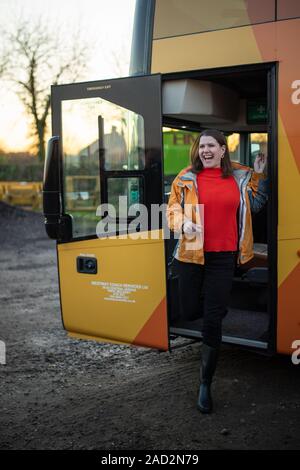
[58,232,167,346]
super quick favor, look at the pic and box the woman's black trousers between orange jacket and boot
[174,251,237,348]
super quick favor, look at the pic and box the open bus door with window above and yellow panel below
[44,75,169,350]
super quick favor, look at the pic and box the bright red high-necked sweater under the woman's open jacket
[197,168,240,251]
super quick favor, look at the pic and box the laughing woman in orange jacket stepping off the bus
[167,129,267,413]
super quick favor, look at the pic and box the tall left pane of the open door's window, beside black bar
[62,99,101,238]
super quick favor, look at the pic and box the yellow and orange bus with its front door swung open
[44,0,300,354]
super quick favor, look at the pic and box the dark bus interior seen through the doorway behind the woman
[162,67,273,349]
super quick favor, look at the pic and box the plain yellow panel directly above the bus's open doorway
[151,26,264,73]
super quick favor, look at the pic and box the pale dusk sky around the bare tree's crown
[0,0,135,151]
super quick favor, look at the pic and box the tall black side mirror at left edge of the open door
[43,136,72,241]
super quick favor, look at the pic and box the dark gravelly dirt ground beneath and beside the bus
[0,203,300,450]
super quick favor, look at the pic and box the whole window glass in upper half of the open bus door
[62,97,145,238]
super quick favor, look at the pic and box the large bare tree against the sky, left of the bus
[6,19,87,161]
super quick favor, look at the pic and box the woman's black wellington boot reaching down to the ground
[197,344,219,413]
